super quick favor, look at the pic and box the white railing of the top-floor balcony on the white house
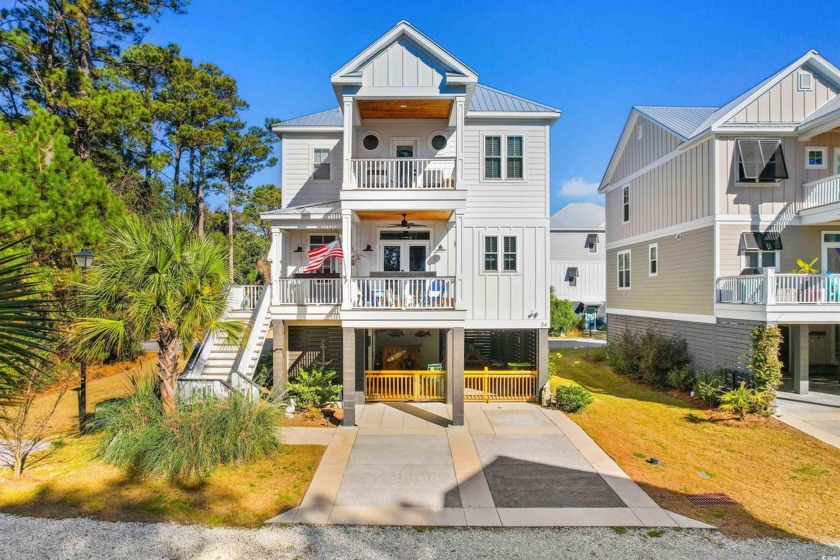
[350,158,455,189]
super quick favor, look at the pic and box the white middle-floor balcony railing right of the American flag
[352,276,455,309]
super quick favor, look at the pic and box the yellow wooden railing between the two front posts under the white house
[365,370,446,401]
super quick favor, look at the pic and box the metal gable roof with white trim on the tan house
[598,50,840,192]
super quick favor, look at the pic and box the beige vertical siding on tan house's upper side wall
[606,140,714,243]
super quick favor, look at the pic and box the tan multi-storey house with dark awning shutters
[599,51,840,393]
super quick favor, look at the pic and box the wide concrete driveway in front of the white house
[269,403,711,528]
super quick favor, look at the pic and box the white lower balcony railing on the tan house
[718,271,840,305]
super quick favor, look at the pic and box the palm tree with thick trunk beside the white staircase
[77,216,243,413]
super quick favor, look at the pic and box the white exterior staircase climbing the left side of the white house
[178,285,271,397]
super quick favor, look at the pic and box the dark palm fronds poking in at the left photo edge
[0,231,55,401]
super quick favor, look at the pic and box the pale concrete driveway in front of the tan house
[776,392,840,449]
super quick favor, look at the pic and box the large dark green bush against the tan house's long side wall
[606,329,691,387]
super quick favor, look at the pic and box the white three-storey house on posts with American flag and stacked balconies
[179,22,560,425]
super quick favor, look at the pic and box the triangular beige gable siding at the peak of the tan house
[726,64,837,124]
